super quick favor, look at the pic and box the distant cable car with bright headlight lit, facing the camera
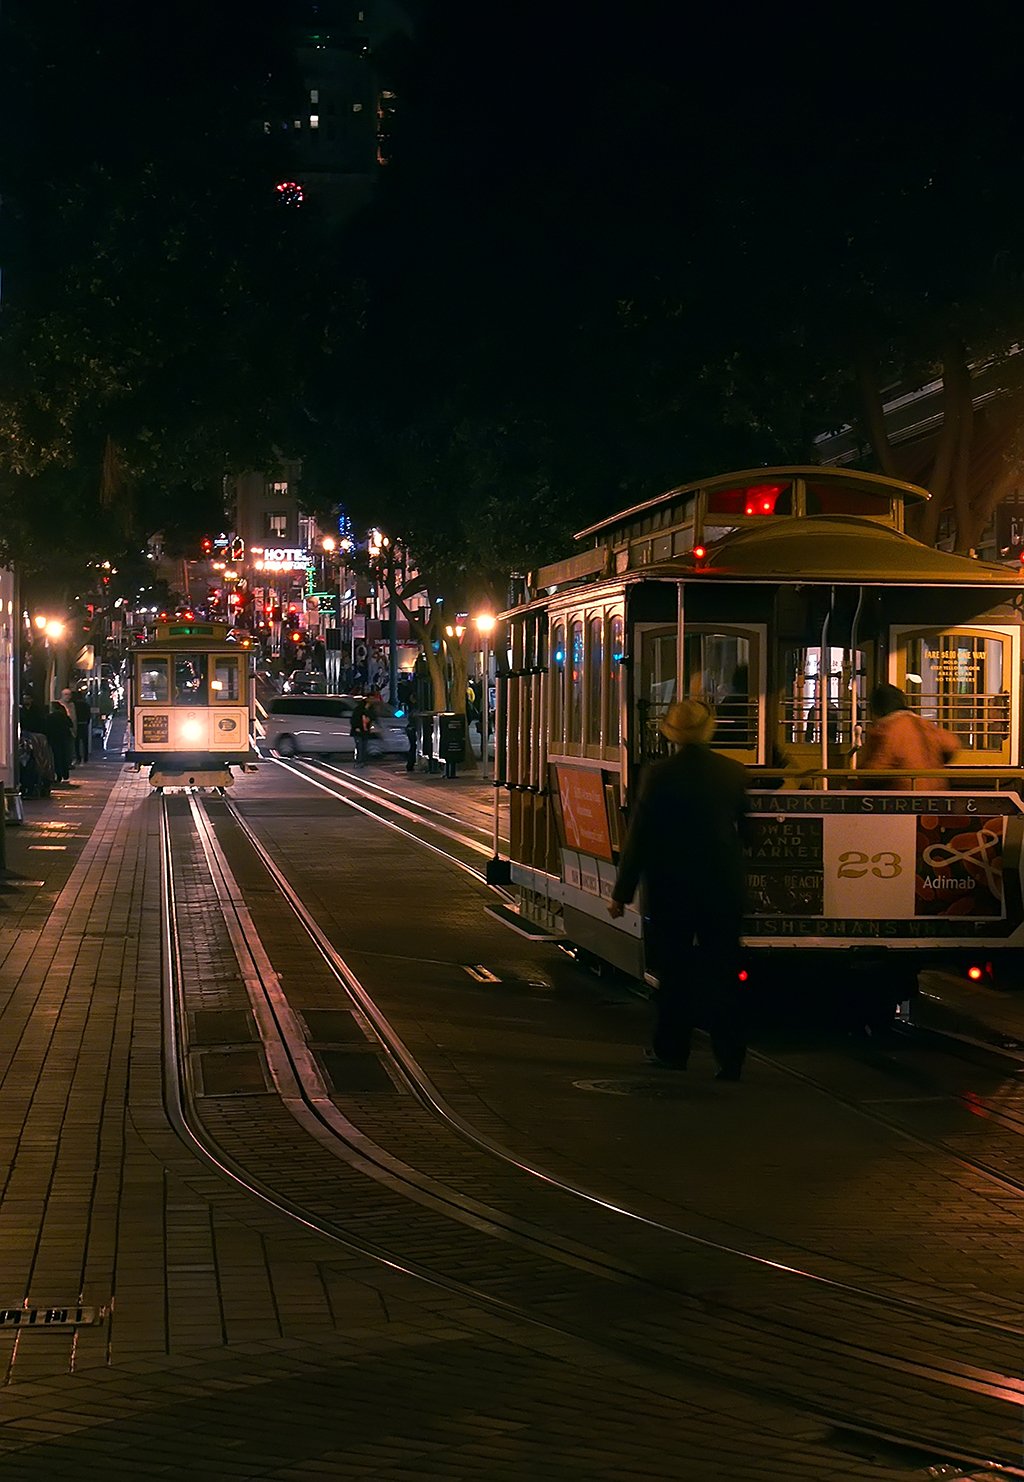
[124,618,256,788]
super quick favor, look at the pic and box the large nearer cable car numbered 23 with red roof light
[496,467,1024,996]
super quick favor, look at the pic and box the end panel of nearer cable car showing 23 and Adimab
[747,793,1024,938]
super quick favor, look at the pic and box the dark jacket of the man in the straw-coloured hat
[612,742,747,926]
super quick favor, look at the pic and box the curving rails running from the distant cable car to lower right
[162,797,1024,1476]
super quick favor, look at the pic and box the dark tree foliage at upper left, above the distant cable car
[0,0,324,562]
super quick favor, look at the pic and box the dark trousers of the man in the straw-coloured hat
[651,911,747,1074]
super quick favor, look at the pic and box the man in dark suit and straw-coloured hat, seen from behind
[608,700,748,1080]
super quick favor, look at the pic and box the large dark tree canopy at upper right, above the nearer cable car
[319,0,1024,566]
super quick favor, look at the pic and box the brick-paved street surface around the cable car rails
[0,746,1024,1482]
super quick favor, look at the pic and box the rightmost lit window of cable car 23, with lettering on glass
[905,633,1009,751]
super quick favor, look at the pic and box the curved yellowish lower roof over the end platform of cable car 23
[681,514,1024,591]
